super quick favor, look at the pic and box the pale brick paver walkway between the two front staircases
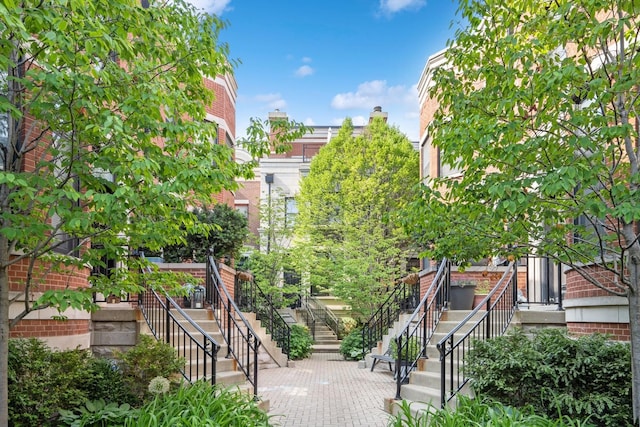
[258,354,395,427]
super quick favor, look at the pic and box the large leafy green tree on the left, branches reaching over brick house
[0,0,304,425]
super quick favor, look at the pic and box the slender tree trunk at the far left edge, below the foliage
[0,235,9,426]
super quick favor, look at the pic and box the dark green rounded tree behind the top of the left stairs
[163,203,249,262]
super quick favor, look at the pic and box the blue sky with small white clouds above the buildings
[191,0,457,141]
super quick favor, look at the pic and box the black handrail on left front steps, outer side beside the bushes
[138,270,220,384]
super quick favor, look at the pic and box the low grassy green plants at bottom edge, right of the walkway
[388,396,593,427]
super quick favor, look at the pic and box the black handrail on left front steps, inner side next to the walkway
[205,256,262,396]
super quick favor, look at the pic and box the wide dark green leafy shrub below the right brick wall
[465,329,633,427]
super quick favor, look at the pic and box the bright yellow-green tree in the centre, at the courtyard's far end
[296,118,419,317]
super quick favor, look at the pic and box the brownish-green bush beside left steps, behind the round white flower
[115,335,185,403]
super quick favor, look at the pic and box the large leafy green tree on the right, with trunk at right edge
[409,0,640,422]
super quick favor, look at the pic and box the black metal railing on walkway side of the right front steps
[394,259,451,399]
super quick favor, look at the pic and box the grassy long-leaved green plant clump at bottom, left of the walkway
[124,381,270,427]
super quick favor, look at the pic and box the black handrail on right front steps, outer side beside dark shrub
[437,262,518,408]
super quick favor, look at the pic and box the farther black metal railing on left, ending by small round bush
[234,275,291,357]
